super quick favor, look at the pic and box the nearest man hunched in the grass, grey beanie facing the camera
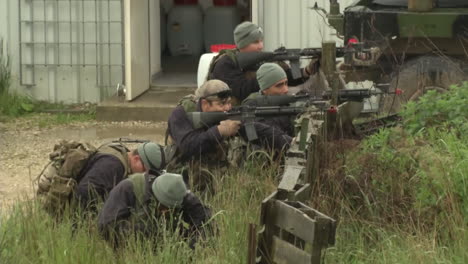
[98,173,211,248]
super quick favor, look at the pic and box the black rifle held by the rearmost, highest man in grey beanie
[236,47,345,79]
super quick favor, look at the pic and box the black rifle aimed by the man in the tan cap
[187,105,304,141]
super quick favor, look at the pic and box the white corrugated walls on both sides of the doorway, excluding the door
[0,0,355,103]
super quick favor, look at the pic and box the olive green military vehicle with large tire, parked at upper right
[328,0,468,111]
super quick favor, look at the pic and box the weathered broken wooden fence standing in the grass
[247,100,356,264]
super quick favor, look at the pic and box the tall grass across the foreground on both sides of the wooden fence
[0,122,468,263]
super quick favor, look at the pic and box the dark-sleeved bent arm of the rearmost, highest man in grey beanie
[212,56,260,101]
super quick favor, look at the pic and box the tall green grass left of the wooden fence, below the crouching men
[0,156,278,264]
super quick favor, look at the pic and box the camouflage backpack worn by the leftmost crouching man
[36,140,129,213]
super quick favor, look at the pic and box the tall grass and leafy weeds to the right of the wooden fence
[312,83,468,263]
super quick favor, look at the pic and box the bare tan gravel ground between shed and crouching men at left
[0,115,166,208]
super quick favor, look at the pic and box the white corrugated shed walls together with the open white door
[0,0,353,103]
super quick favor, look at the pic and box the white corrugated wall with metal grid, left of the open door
[0,0,124,103]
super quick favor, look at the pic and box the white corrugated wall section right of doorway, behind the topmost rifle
[258,0,355,51]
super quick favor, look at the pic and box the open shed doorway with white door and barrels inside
[125,0,251,100]
